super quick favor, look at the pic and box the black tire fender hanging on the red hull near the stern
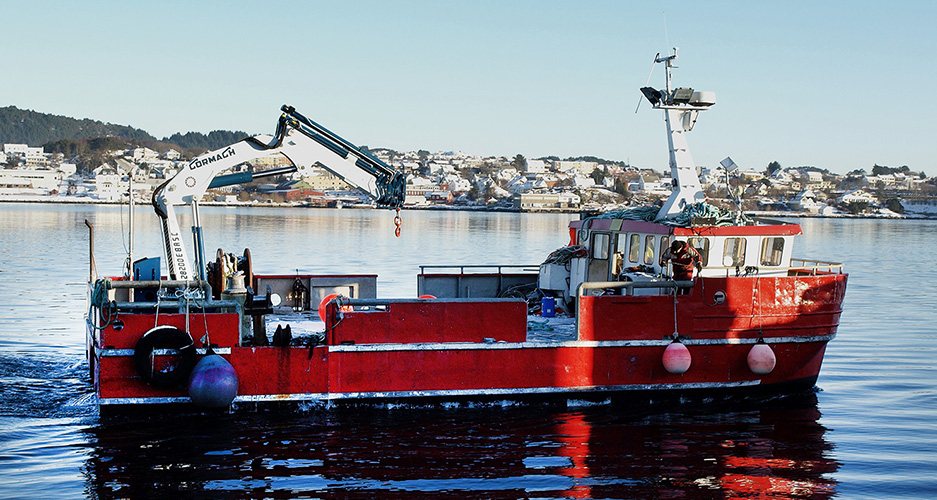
[133,325,196,389]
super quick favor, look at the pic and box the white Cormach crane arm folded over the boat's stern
[153,105,406,281]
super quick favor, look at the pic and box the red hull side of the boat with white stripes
[93,274,846,406]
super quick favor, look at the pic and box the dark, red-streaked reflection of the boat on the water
[84,394,839,499]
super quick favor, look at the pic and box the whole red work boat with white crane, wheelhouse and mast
[86,50,847,413]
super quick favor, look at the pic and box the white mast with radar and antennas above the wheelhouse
[641,47,716,220]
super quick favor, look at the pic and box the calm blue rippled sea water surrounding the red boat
[0,204,937,499]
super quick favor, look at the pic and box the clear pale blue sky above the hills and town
[0,0,937,175]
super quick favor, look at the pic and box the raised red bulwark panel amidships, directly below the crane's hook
[330,300,527,345]
